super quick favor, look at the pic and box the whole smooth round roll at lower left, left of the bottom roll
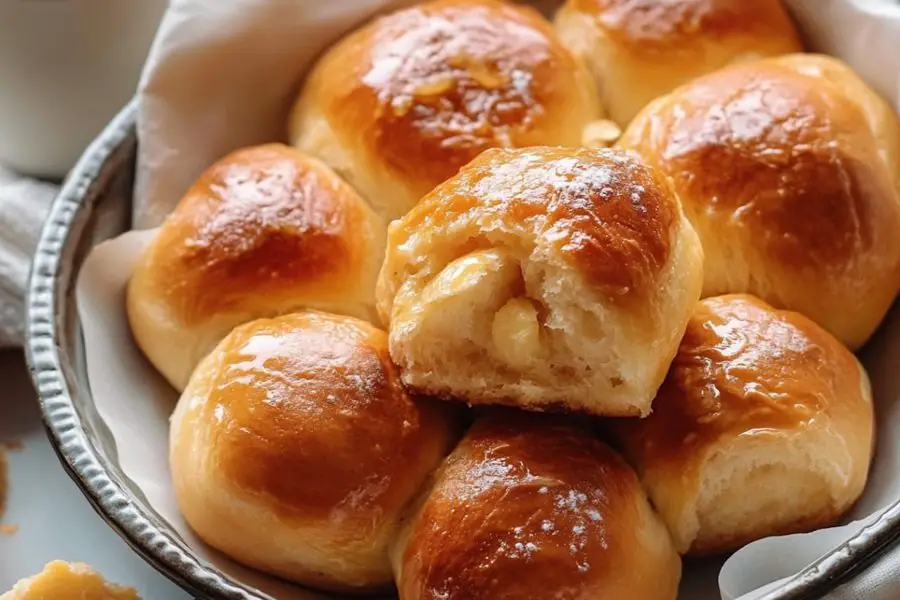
[170,312,453,590]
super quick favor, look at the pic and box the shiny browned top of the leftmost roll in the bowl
[154,144,369,323]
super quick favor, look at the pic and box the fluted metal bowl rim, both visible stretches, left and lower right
[25,100,900,600]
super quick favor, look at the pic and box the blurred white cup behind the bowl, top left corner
[0,0,166,178]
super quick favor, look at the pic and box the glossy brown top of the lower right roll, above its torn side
[621,294,871,469]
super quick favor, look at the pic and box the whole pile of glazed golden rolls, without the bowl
[127,0,900,600]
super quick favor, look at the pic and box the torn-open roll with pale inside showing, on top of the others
[376,147,703,415]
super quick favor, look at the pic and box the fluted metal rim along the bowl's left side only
[25,100,270,600]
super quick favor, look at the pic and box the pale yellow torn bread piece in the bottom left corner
[0,560,140,600]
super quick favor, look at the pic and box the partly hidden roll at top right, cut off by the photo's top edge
[556,0,802,125]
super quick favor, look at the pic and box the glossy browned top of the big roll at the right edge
[622,62,900,272]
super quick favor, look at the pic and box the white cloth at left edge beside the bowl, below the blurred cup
[0,166,58,348]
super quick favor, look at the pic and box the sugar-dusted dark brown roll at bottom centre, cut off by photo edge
[391,413,681,600]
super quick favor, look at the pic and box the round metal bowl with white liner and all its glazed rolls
[22,0,900,600]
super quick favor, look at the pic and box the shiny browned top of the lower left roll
[202,313,449,527]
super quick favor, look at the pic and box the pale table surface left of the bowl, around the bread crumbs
[0,350,190,600]
